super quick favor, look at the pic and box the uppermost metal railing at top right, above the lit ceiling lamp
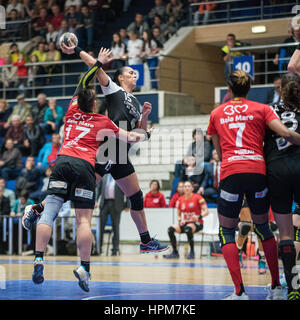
[189,0,299,25]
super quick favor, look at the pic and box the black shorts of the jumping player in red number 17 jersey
[47,155,96,209]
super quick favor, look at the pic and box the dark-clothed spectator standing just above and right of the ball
[77,6,95,50]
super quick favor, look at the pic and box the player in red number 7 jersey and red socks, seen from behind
[208,70,300,300]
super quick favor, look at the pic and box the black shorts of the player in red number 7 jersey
[218,173,269,219]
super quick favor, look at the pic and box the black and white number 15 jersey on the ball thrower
[101,78,142,131]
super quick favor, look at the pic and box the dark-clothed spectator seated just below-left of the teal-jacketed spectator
[21,115,45,157]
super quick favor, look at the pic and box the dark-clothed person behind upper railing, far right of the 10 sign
[273,26,300,71]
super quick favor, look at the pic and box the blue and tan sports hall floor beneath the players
[0,254,288,300]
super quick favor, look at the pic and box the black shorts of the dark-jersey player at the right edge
[267,156,300,214]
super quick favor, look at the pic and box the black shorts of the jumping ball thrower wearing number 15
[95,161,135,180]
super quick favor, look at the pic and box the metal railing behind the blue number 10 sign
[229,42,299,84]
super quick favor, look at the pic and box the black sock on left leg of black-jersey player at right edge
[279,240,299,292]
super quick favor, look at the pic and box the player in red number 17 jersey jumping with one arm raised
[23,45,150,291]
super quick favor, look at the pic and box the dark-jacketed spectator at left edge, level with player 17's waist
[0,139,23,180]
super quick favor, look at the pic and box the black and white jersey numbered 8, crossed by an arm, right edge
[264,102,300,164]
